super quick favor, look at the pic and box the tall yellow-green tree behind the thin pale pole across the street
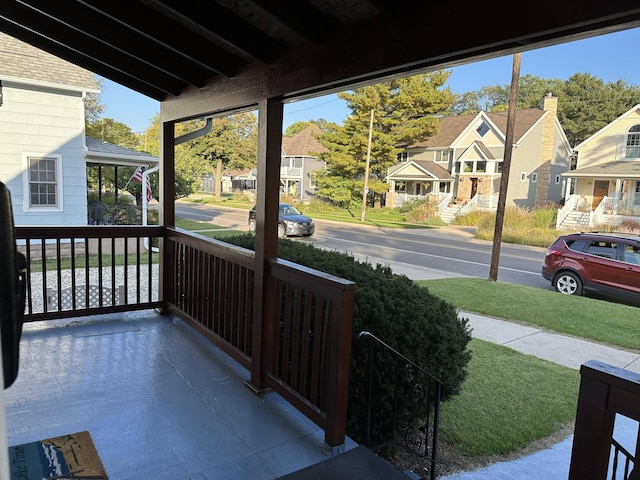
[317,71,454,205]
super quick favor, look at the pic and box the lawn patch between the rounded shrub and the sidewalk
[440,339,580,457]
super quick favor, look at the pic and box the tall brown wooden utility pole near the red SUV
[489,52,522,282]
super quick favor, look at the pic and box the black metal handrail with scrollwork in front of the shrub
[358,331,443,480]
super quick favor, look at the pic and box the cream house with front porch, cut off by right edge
[558,104,640,229]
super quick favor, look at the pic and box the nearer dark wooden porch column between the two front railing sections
[247,98,283,393]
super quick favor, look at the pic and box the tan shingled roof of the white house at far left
[0,32,98,92]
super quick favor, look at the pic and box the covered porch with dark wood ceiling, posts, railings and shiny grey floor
[0,0,640,479]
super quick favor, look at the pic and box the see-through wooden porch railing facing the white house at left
[15,226,162,322]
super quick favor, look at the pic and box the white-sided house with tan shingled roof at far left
[0,33,158,226]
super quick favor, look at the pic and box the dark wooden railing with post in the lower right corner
[569,360,640,480]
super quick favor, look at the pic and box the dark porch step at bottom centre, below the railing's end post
[278,445,416,480]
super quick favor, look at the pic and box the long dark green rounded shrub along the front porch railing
[225,235,471,441]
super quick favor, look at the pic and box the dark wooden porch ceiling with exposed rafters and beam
[0,0,640,120]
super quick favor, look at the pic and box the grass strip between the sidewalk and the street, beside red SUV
[416,278,640,350]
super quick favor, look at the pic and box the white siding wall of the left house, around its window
[0,82,87,225]
